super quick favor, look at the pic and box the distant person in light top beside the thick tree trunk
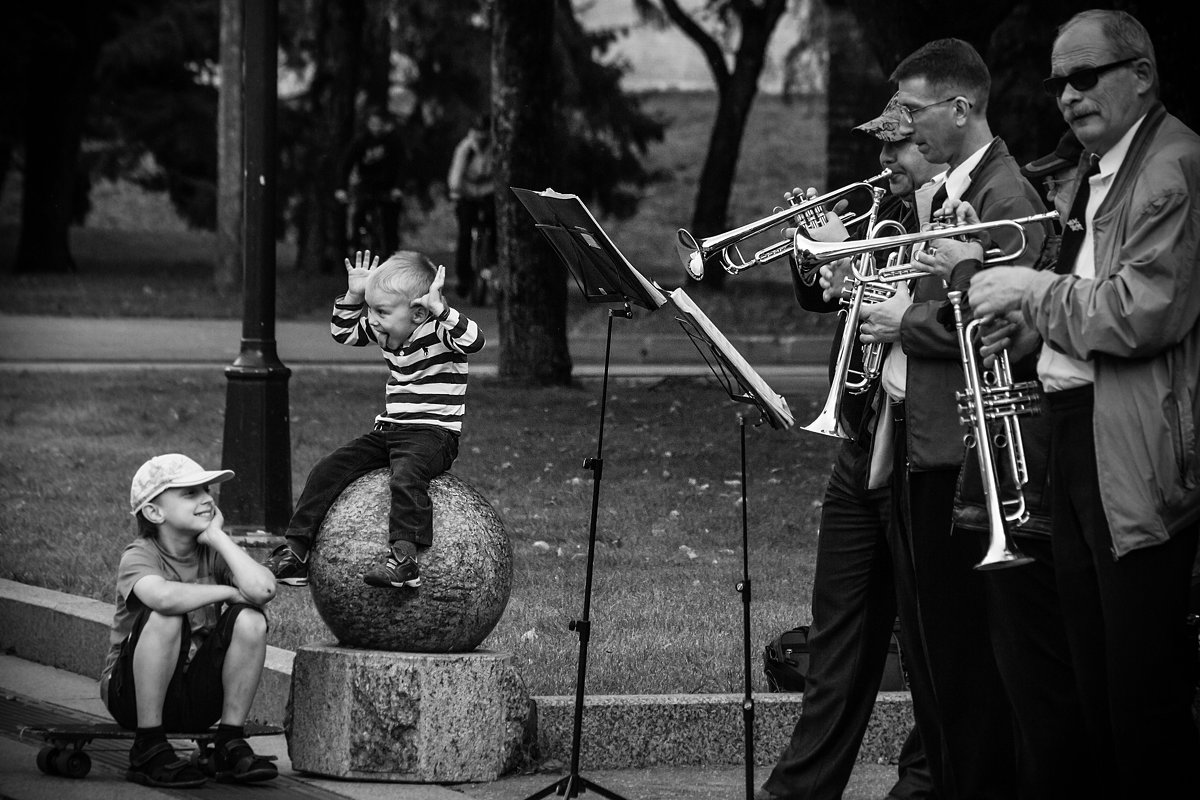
[446,114,496,297]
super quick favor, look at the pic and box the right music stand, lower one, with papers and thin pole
[670,289,796,800]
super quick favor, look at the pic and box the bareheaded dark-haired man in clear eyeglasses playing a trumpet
[860,38,1048,798]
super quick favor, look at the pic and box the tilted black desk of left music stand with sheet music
[512,187,667,311]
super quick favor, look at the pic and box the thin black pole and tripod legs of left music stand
[526,303,634,800]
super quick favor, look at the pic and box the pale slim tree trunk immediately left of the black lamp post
[212,0,244,293]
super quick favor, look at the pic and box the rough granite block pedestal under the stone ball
[289,645,533,783]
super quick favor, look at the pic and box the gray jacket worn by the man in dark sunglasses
[1024,104,1200,558]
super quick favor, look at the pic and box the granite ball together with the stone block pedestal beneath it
[288,469,533,783]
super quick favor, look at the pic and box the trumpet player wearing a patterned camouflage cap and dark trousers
[755,95,944,800]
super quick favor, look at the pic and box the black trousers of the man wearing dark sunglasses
[1046,387,1200,798]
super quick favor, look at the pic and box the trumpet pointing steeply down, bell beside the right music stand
[804,194,904,439]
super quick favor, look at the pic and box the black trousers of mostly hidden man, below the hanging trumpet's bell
[983,535,1108,800]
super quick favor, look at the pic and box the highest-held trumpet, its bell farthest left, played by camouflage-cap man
[676,169,892,281]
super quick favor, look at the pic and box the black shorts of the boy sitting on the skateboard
[108,603,262,733]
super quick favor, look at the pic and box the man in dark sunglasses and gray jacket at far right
[970,11,1200,798]
